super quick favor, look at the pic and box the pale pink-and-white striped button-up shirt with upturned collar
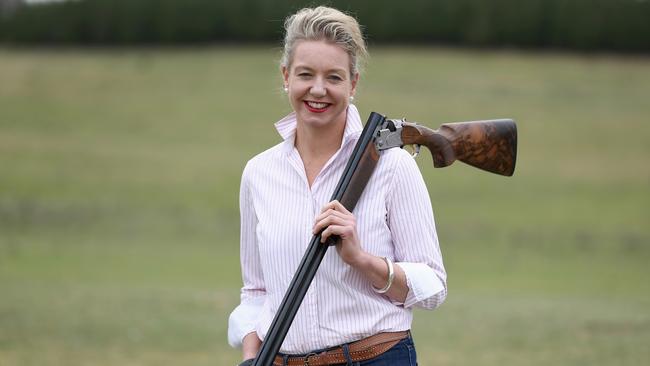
[228,105,447,354]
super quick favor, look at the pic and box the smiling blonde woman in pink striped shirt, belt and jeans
[228,7,447,366]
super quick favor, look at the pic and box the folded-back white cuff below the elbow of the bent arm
[396,262,445,308]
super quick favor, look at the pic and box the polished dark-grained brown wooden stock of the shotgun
[402,119,517,176]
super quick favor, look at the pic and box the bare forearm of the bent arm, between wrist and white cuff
[351,252,409,303]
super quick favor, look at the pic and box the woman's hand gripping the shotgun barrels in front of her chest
[313,200,365,266]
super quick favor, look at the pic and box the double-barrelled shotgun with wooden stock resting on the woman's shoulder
[249,112,517,366]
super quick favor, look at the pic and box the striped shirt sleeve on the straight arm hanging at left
[228,166,266,347]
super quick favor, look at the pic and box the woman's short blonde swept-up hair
[280,6,368,76]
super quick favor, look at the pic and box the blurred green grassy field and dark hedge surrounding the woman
[0,0,650,366]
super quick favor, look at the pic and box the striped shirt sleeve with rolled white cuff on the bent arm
[387,152,447,309]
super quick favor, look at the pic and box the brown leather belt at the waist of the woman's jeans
[273,330,409,366]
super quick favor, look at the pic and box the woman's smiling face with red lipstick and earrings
[282,41,359,128]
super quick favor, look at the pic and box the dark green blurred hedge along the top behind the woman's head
[0,0,650,52]
